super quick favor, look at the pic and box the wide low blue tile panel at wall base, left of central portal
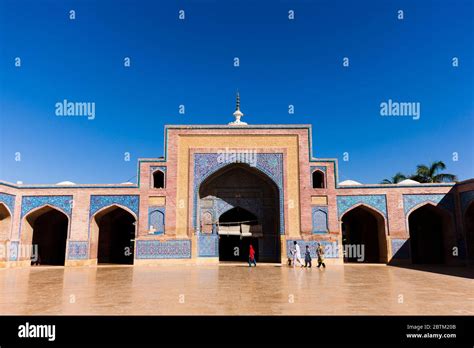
[135,239,191,259]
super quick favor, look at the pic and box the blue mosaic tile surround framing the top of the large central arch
[193,153,285,234]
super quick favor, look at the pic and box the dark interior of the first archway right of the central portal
[342,207,380,263]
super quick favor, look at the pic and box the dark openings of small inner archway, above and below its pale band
[219,207,259,261]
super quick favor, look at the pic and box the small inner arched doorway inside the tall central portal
[218,207,261,261]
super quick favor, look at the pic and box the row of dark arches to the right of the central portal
[341,203,466,264]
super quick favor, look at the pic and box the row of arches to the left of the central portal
[0,203,136,266]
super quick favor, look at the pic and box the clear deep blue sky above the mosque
[0,0,474,183]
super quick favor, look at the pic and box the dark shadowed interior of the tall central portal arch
[199,164,281,262]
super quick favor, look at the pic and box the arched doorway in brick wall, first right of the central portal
[341,205,387,263]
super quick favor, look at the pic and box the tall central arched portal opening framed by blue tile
[198,163,281,263]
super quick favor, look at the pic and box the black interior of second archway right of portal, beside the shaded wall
[408,205,443,264]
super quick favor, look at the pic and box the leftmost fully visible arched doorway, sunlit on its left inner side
[22,206,69,266]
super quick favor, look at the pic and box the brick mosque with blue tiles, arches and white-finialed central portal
[0,97,474,267]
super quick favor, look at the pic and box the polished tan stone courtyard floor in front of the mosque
[0,265,474,315]
